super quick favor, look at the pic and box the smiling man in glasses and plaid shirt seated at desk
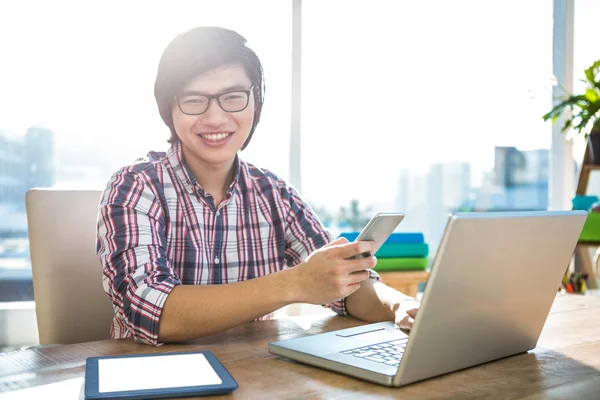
[97,27,418,345]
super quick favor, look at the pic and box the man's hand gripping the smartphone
[290,238,377,304]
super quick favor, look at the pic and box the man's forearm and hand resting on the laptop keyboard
[346,279,419,330]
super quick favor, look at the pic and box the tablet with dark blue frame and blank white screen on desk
[85,350,238,399]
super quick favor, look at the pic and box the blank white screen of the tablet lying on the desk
[98,354,222,393]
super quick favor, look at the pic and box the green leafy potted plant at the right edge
[543,60,600,164]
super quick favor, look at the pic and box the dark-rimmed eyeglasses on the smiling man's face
[176,87,253,115]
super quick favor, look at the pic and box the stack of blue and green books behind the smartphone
[340,232,429,271]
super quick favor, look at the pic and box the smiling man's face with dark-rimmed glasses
[172,65,254,166]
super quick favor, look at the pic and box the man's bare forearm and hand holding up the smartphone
[159,240,375,342]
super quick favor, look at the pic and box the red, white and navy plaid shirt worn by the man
[97,142,354,345]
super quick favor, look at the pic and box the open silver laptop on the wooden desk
[269,211,587,387]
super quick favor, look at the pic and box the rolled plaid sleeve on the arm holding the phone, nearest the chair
[97,169,181,346]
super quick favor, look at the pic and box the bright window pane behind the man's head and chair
[0,1,291,302]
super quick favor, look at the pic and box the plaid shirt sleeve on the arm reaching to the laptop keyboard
[285,186,381,315]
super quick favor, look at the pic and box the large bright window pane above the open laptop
[302,0,553,252]
